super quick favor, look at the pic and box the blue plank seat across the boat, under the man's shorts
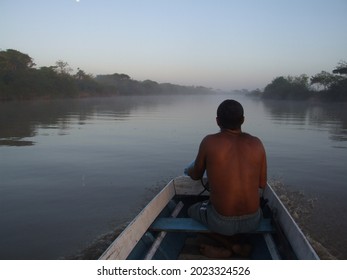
[150,218,275,233]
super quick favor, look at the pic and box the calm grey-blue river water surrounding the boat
[0,94,347,259]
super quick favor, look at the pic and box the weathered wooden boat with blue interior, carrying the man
[100,176,319,260]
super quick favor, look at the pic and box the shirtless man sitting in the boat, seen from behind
[186,100,267,257]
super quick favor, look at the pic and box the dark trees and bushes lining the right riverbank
[251,61,347,101]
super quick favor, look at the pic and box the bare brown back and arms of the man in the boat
[191,129,266,216]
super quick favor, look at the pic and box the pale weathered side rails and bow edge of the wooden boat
[99,176,319,260]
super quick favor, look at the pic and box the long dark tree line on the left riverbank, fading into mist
[0,49,211,100]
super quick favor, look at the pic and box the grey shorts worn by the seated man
[188,200,262,235]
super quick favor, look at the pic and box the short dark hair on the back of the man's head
[217,99,244,129]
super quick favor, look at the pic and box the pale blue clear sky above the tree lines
[0,0,347,89]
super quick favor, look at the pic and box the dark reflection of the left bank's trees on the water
[0,96,178,146]
